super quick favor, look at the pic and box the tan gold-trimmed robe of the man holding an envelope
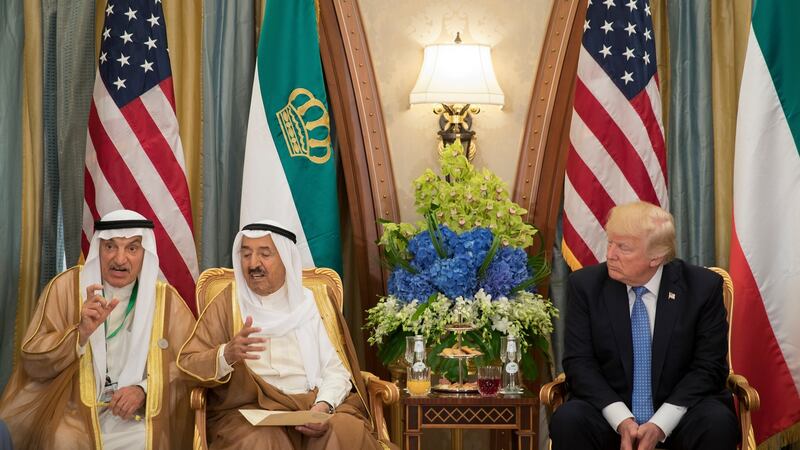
[178,283,386,450]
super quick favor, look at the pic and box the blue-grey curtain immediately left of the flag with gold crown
[200,1,256,270]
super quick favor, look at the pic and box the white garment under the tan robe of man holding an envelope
[217,285,352,408]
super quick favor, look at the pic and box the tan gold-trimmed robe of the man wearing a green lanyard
[0,266,194,450]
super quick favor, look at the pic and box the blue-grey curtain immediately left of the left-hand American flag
[39,0,95,287]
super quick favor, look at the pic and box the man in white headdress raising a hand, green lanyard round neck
[0,210,194,450]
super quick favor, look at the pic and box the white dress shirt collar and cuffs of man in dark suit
[603,266,686,442]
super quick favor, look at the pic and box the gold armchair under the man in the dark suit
[539,267,761,450]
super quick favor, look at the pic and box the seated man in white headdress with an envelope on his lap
[178,220,382,450]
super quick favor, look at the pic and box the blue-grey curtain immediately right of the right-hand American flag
[667,0,716,265]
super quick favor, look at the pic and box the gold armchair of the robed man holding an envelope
[189,268,400,450]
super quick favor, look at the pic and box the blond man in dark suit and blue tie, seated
[550,202,739,450]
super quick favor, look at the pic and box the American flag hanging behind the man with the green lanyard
[82,0,198,310]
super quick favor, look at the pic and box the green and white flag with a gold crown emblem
[240,0,342,274]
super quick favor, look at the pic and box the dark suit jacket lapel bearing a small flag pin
[651,262,686,398]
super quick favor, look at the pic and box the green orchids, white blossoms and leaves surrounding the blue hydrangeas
[364,141,558,381]
